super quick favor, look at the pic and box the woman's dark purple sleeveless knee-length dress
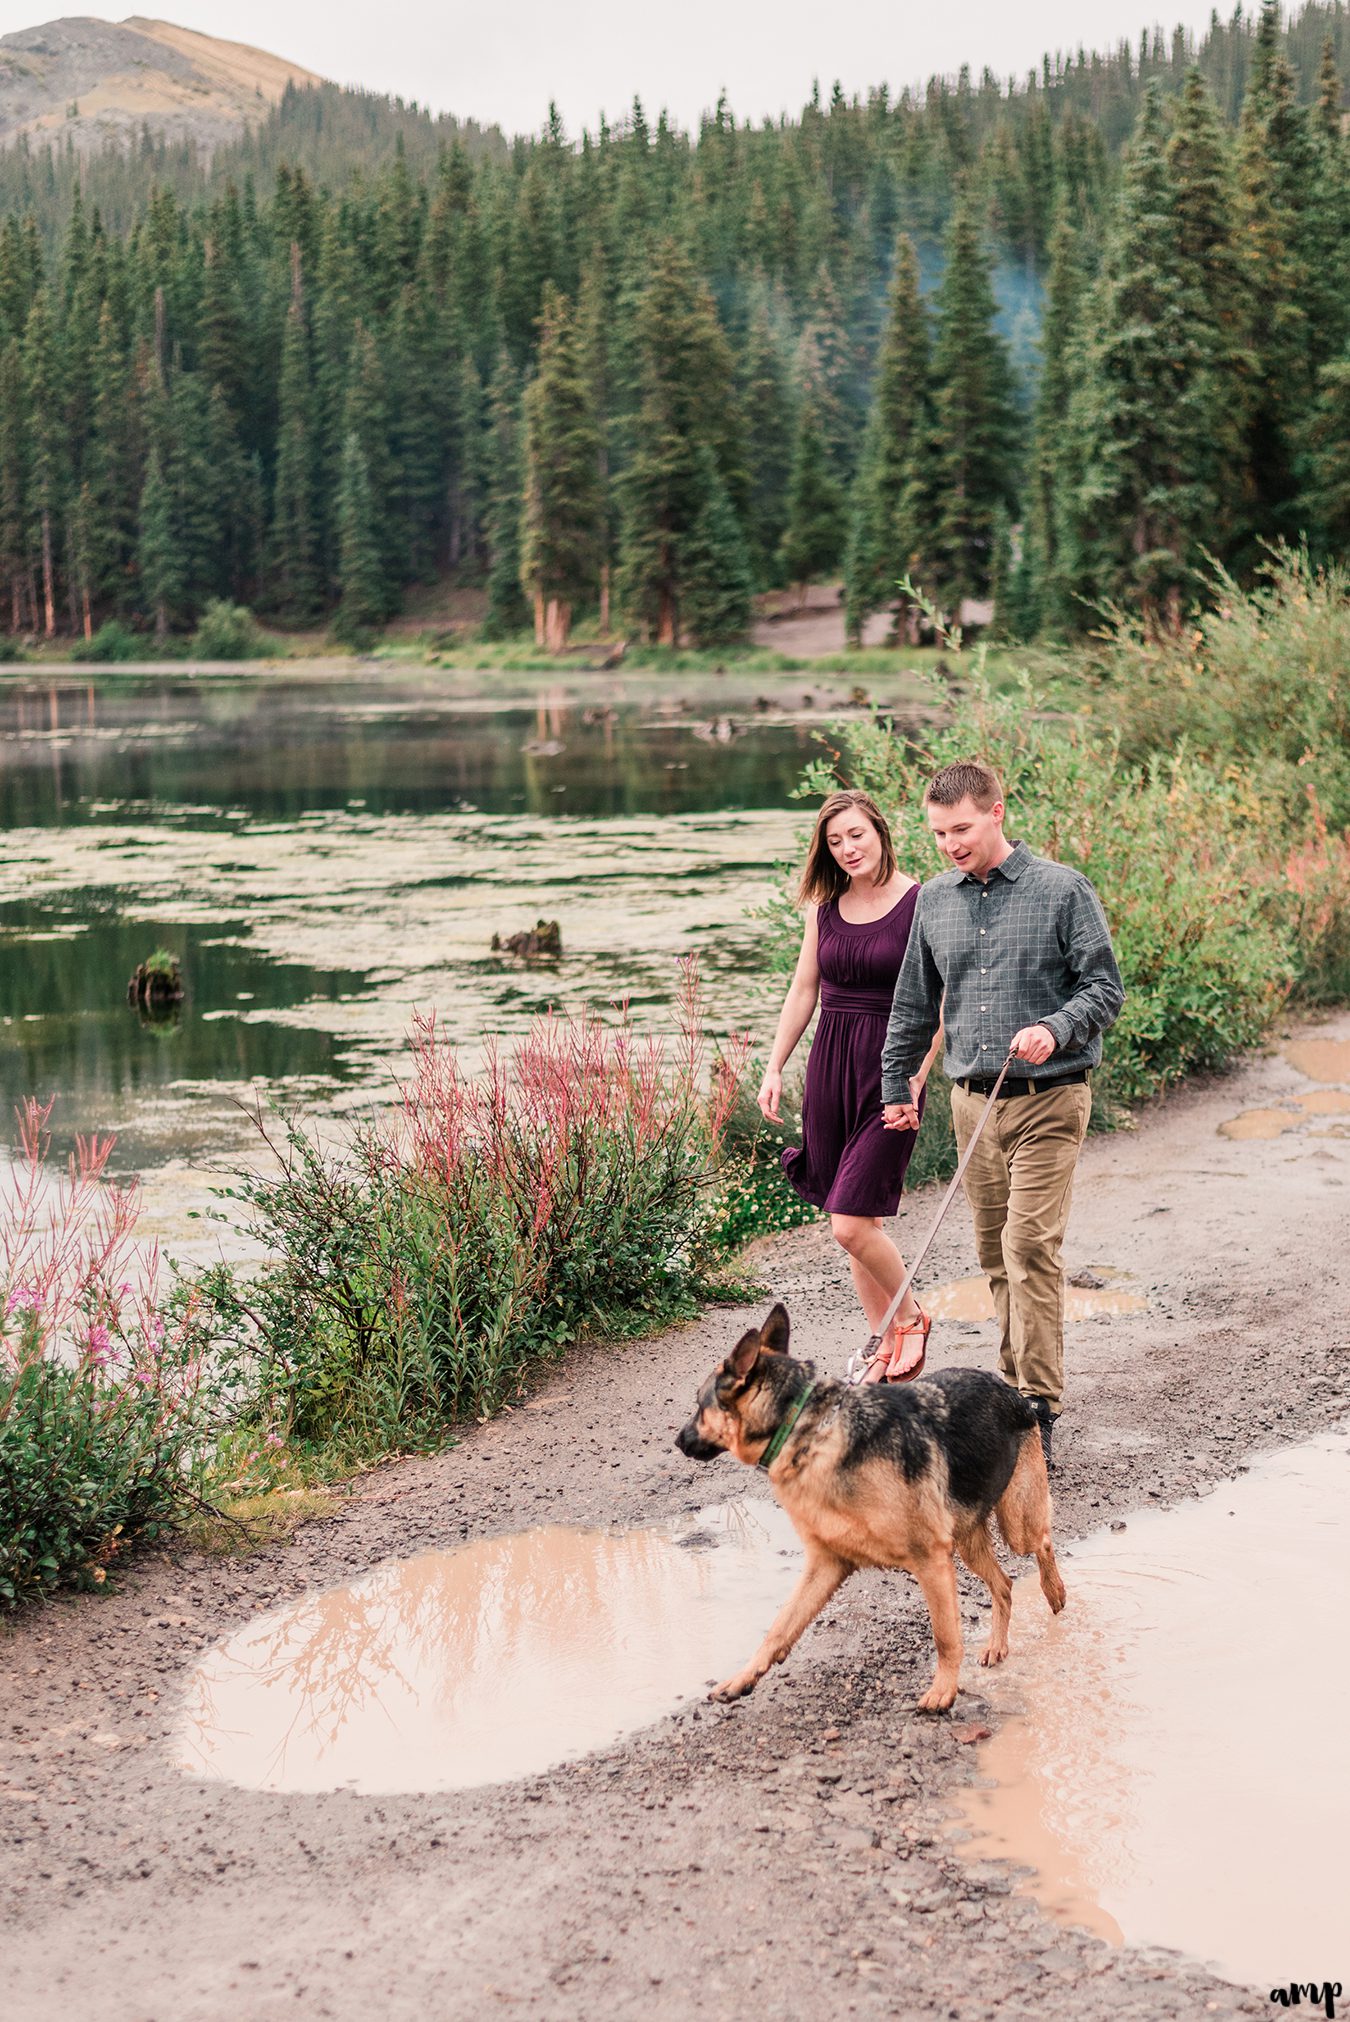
[782,886,920,1215]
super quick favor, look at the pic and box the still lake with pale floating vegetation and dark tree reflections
[0,669,864,1171]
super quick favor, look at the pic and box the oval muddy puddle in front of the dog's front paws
[178,1498,800,1791]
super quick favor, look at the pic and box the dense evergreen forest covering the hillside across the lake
[0,4,1350,649]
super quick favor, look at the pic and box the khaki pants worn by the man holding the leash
[952,1082,1091,1413]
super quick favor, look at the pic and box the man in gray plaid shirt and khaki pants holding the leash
[881,764,1126,1464]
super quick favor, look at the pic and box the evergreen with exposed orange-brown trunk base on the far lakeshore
[521,285,604,653]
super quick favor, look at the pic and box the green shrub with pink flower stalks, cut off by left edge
[0,1102,202,1607]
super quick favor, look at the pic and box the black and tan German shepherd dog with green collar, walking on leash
[675,1306,1065,1713]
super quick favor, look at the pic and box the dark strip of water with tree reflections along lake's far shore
[0,673,836,829]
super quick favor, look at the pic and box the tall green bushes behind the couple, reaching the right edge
[768,552,1350,1169]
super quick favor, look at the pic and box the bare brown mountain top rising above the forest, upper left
[0,14,323,152]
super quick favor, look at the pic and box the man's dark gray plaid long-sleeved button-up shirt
[881,843,1126,1102]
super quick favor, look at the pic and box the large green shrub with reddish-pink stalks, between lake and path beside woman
[194,986,747,1462]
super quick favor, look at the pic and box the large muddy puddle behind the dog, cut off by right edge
[960,1428,1350,1988]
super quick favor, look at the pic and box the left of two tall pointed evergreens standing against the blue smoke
[845,237,936,645]
